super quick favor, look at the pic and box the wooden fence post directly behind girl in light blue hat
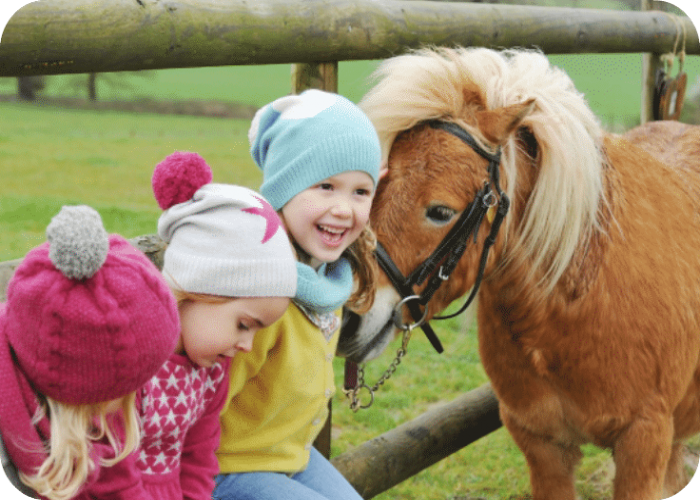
[292,61,338,458]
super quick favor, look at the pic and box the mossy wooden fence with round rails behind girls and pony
[0,0,700,498]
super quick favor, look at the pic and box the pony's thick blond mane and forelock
[360,48,605,289]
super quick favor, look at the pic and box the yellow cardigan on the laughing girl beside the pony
[217,304,339,474]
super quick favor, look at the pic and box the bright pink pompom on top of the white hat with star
[151,151,212,210]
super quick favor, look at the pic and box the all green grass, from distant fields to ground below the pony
[0,2,700,500]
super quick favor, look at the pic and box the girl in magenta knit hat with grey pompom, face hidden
[0,206,179,500]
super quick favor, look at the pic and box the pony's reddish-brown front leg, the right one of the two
[613,414,673,500]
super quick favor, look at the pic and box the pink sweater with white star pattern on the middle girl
[100,354,230,500]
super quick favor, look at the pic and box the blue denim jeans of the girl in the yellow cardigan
[212,448,362,500]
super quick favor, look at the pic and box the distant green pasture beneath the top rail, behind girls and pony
[0,54,700,261]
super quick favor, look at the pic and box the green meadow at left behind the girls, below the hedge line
[0,103,261,261]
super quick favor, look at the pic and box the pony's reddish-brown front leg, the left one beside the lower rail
[501,411,582,500]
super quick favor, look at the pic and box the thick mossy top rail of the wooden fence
[0,0,700,76]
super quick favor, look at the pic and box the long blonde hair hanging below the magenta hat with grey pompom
[19,392,140,500]
